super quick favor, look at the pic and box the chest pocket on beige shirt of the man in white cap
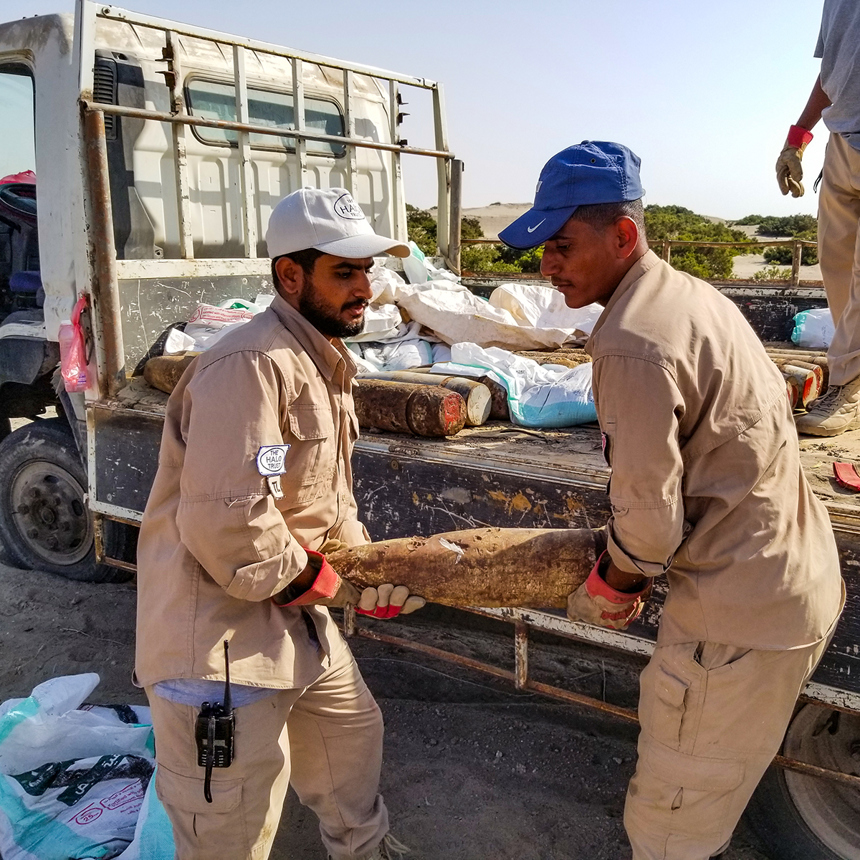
[281,405,337,505]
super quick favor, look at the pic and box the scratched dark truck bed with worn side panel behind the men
[101,340,860,694]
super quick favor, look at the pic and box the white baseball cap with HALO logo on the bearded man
[266,188,411,259]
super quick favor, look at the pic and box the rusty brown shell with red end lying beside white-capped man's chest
[355,379,466,436]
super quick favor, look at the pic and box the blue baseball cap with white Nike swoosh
[499,140,645,250]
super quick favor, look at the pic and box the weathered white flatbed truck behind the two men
[0,0,860,860]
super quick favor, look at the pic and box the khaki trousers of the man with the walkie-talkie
[146,639,388,860]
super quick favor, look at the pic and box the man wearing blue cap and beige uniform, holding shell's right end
[499,141,843,860]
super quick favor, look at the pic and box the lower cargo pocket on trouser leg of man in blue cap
[631,743,744,834]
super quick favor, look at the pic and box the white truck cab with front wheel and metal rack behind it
[0,0,453,579]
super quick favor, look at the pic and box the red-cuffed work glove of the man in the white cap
[272,547,426,618]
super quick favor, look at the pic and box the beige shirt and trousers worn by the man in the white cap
[136,296,388,860]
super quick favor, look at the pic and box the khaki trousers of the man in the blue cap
[624,636,830,860]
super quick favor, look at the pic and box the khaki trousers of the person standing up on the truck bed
[818,134,860,385]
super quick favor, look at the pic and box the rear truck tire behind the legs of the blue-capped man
[746,705,860,860]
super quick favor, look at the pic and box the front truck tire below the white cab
[0,418,134,582]
